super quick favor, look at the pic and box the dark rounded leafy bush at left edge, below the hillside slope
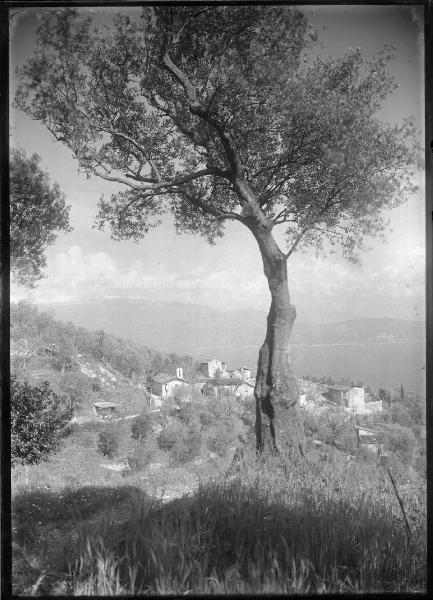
[11,375,72,464]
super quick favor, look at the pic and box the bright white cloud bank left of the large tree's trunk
[11,246,267,309]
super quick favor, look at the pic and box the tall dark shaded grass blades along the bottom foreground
[66,482,425,594]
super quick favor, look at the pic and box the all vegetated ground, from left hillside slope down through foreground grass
[12,304,426,595]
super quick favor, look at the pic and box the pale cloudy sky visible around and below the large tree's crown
[10,6,425,323]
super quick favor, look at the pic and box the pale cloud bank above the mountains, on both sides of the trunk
[12,240,425,322]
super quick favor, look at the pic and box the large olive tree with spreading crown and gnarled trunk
[16,5,419,450]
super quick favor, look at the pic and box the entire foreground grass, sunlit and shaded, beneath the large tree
[14,432,426,595]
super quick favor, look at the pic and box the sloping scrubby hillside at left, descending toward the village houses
[11,303,196,413]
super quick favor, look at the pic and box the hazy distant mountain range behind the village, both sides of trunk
[35,298,425,358]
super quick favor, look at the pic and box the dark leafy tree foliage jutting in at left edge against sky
[9,149,71,287]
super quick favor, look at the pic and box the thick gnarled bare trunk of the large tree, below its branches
[251,226,299,452]
